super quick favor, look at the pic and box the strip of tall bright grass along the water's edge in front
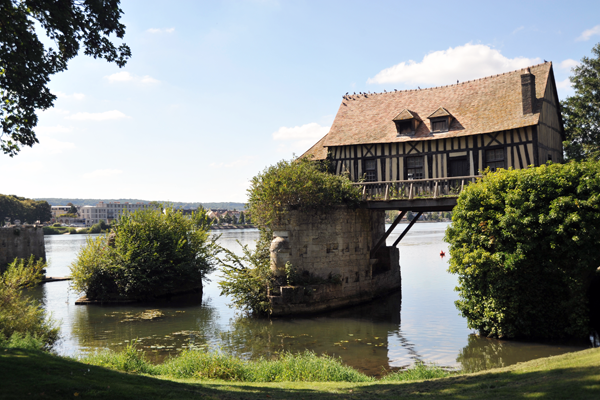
[82,345,456,382]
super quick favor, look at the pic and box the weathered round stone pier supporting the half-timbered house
[270,207,401,315]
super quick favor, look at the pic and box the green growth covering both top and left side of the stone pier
[219,157,361,313]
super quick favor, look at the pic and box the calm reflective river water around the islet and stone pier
[35,223,586,376]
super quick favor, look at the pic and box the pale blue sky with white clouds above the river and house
[0,0,600,202]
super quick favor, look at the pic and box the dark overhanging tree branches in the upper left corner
[0,0,131,157]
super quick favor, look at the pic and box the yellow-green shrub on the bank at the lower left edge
[0,256,58,347]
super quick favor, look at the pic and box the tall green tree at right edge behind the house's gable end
[561,43,600,160]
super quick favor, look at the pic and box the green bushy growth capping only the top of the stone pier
[247,158,361,228]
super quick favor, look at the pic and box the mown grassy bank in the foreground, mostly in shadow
[0,349,600,400]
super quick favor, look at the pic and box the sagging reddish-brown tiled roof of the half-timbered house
[318,63,552,149]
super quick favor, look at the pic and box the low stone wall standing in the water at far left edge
[0,225,46,267]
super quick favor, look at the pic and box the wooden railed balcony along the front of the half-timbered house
[354,175,481,211]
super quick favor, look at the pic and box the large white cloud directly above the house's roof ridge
[367,43,541,85]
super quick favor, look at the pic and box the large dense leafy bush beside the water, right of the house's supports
[445,162,600,338]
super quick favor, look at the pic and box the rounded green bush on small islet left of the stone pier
[71,207,218,300]
